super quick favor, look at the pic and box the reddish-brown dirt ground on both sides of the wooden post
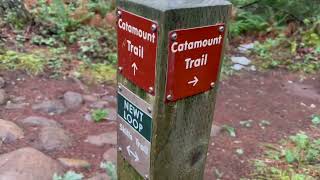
[0,70,320,180]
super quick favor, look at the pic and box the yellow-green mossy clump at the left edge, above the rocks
[0,51,46,75]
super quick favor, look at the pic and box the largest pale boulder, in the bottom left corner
[0,148,63,180]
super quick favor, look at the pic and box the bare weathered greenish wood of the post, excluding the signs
[117,0,231,180]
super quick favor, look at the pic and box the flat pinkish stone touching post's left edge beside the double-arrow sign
[85,131,117,146]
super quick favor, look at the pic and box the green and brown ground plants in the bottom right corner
[252,132,320,180]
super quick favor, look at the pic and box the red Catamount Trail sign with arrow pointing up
[117,9,158,95]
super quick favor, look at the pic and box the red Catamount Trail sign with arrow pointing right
[166,24,225,102]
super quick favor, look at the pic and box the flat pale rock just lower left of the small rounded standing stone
[32,100,66,114]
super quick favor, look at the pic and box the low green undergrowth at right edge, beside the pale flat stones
[253,32,320,73]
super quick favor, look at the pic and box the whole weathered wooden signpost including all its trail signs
[117,0,231,180]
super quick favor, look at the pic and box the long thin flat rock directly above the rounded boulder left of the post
[20,116,62,127]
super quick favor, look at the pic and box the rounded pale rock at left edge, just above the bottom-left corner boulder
[0,119,24,143]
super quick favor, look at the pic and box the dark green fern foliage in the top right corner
[230,0,320,37]
